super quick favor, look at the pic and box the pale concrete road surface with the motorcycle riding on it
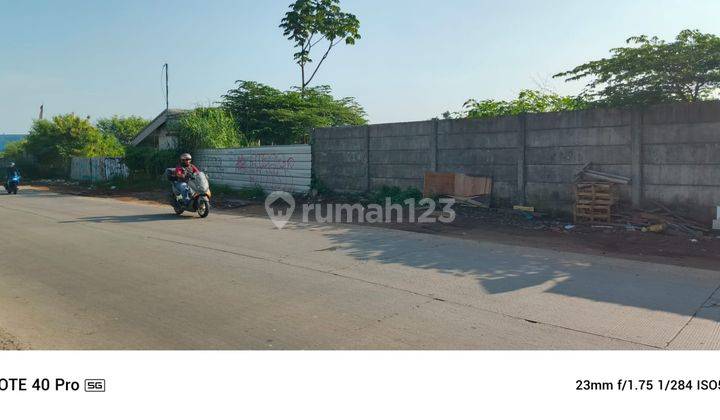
[0,190,720,349]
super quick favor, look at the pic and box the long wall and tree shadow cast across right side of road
[288,227,720,316]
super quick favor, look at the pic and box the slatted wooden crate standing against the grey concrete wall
[573,182,617,223]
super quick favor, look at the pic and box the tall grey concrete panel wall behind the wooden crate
[313,101,720,219]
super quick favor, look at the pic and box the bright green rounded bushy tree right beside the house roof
[171,108,248,152]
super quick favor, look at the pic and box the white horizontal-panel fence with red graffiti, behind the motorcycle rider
[194,145,312,193]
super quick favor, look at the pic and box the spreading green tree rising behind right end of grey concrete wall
[554,30,720,106]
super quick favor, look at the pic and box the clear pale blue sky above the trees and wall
[0,0,720,133]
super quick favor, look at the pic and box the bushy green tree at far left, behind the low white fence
[24,114,125,169]
